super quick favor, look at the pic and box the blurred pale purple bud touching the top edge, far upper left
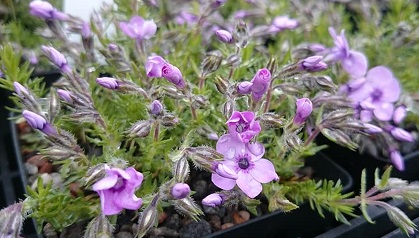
[29,0,68,20]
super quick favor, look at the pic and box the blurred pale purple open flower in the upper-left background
[119,16,157,41]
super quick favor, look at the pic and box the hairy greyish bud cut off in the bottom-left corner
[0,202,24,238]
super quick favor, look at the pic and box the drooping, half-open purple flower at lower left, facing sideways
[93,165,143,215]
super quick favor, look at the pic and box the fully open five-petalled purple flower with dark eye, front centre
[211,134,279,198]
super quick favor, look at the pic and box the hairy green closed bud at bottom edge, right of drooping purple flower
[136,196,159,237]
